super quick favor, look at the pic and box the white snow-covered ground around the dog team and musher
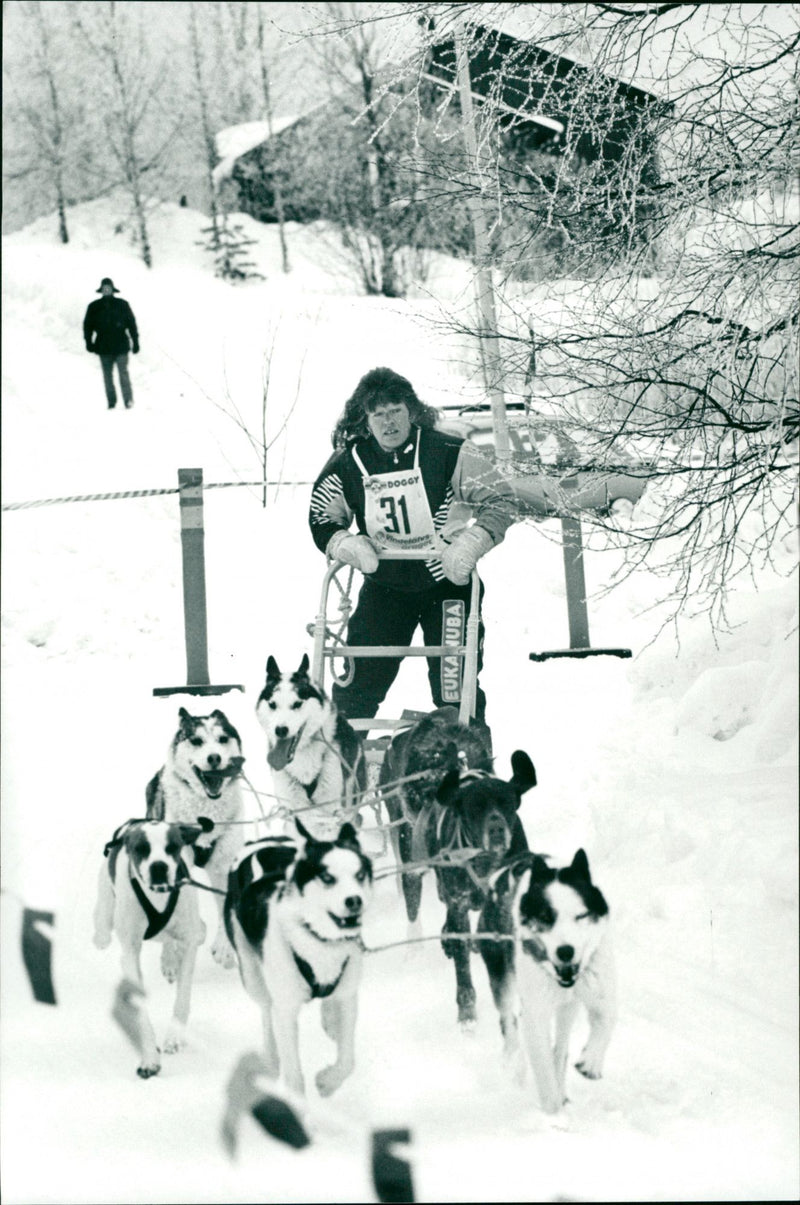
[1,201,800,1205]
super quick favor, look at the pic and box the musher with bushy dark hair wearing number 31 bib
[308,368,518,735]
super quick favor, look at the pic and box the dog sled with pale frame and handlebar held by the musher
[308,549,481,778]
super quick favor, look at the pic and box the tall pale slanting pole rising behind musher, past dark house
[455,22,511,462]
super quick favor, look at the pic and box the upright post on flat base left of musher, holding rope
[153,469,243,695]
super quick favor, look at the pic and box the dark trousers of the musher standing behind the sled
[331,577,486,724]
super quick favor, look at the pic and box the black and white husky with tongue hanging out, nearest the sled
[255,656,366,840]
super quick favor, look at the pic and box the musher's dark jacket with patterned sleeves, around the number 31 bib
[308,425,517,590]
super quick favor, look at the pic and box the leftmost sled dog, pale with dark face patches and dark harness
[94,821,205,1080]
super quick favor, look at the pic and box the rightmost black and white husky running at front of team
[480,850,617,1113]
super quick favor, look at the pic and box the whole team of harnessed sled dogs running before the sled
[94,657,616,1112]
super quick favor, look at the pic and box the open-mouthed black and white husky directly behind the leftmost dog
[145,707,245,968]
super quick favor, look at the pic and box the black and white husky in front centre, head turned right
[225,821,372,1095]
